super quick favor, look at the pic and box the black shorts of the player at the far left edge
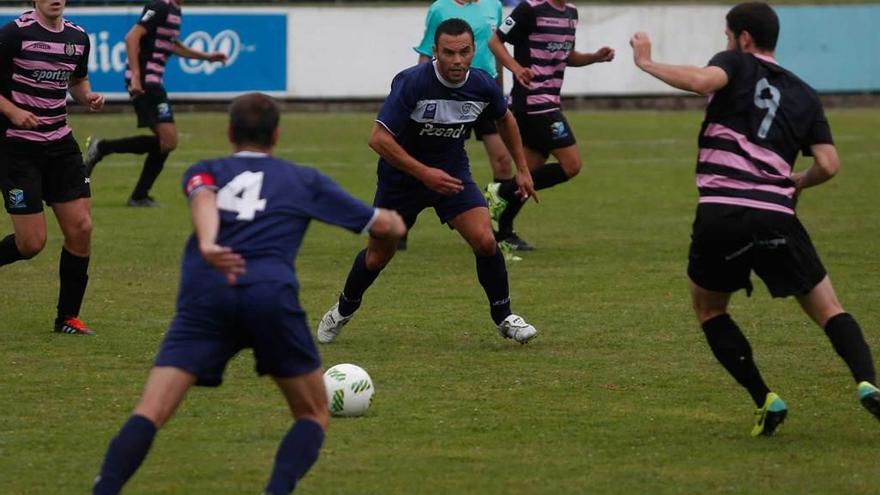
[0,134,92,215]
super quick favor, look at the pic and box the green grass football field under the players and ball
[0,109,880,494]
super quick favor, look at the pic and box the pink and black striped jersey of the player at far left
[0,11,89,142]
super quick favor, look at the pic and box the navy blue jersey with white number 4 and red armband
[178,152,375,301]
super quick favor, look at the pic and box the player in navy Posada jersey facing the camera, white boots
[318,19,537,344]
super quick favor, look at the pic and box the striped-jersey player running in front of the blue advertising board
[85,0,226,207]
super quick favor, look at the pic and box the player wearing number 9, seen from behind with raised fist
[630,2,880,436]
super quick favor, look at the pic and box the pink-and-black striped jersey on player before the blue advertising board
[125,0,181,87]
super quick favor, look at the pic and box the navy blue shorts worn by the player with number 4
[155,282,321,387]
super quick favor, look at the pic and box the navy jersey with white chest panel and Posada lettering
[376,62,507,186]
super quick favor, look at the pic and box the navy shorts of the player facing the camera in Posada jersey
[373,177,486,229]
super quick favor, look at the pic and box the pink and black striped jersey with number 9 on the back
[697,50,834,215]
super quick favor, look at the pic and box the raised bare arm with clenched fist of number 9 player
[629,32,728,95]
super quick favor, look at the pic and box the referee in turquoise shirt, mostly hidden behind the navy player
[410,0,513,252]
